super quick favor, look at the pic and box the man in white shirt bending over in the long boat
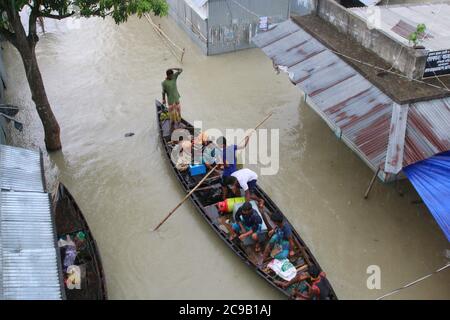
[222,168,264,209]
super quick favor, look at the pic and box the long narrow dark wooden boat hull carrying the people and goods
[156,101,337,300]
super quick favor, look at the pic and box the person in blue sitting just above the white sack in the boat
[263,212,295,260]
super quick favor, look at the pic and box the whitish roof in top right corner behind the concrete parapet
[350,2,450,51]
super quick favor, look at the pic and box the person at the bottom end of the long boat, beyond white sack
[276,265,331,300]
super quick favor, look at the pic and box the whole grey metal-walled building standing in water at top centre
[167,0,290,55]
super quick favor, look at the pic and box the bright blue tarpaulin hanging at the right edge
[403,151,450,241]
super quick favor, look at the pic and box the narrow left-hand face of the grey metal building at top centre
[167,0,208,54]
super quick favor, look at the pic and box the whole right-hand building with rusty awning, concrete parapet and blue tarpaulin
[253,0,450,241]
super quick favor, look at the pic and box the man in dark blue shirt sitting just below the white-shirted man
[230,202,262,252]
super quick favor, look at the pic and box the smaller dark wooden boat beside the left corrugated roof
[53,183,108,300]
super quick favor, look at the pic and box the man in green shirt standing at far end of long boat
[161,68,183,131]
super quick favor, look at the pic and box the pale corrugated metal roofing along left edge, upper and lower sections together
[0,145,62,300]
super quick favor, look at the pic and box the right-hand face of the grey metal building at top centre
[208,0,290,55]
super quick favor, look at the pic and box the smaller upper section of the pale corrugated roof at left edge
[0,145,44,192]
